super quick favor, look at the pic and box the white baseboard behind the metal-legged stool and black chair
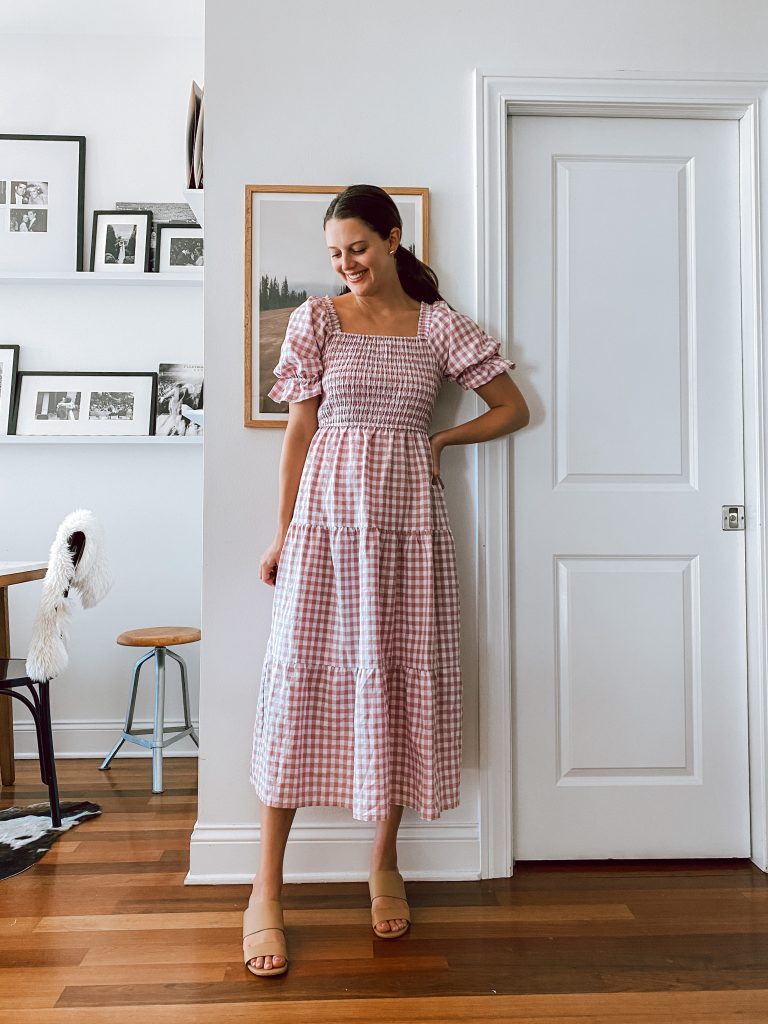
[13,718,200,761]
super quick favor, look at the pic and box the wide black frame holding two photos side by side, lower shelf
[11,370,158,437]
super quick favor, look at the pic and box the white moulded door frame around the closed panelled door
[474,69,768,878]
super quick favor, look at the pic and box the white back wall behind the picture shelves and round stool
[0,9,203,761]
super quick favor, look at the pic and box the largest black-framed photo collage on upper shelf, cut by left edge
[0,134,85,273]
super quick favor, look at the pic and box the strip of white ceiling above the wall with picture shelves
[0,0,205,36]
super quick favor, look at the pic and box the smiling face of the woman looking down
[326,217,400,295]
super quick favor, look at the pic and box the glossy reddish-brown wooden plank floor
[0,759,768,1024]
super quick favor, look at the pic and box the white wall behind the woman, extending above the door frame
[190,0,768,881]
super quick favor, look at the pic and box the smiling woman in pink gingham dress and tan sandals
[244,185,528,977]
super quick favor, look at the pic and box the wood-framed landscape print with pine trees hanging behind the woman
[244,185,429,427]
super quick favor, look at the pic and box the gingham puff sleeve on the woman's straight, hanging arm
[267,295,326,401]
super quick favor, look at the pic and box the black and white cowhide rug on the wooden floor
[0,800,101,879]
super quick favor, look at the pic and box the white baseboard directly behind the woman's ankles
[184,819,480,885]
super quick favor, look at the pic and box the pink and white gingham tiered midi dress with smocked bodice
[251,295,515,821]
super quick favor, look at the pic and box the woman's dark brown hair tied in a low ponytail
[323,185,442,302]
